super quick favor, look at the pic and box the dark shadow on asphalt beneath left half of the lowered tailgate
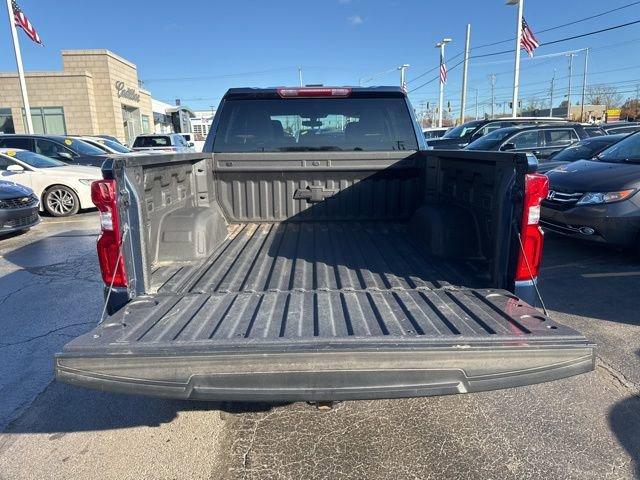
[4,381,286,435]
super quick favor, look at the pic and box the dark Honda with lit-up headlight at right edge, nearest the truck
[540,133,640,253]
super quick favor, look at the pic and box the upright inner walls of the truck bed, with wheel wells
[115,151,518,294]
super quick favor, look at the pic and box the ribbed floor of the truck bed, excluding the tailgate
[152,222,488,293]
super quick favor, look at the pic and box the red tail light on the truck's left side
[91,180,127,287]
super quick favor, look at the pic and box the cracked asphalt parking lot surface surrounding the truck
[0,212,640,479]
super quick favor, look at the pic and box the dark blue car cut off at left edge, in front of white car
[0,179,40,235]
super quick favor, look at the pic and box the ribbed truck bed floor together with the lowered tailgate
[56,222,595,401]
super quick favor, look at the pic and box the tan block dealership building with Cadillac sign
[0,50,193,145]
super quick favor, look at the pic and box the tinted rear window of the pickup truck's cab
[213,98,418,153]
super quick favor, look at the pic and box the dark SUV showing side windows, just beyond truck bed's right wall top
[465,123,589,166]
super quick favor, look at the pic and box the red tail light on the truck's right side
[516,173,549,281]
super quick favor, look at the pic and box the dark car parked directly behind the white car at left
[0,134,107,167]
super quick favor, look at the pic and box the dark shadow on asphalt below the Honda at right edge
[540,234,640,325]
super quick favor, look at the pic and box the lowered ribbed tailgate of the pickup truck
[55,289,595,401]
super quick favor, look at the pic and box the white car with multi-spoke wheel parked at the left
[0,148,102,217]
